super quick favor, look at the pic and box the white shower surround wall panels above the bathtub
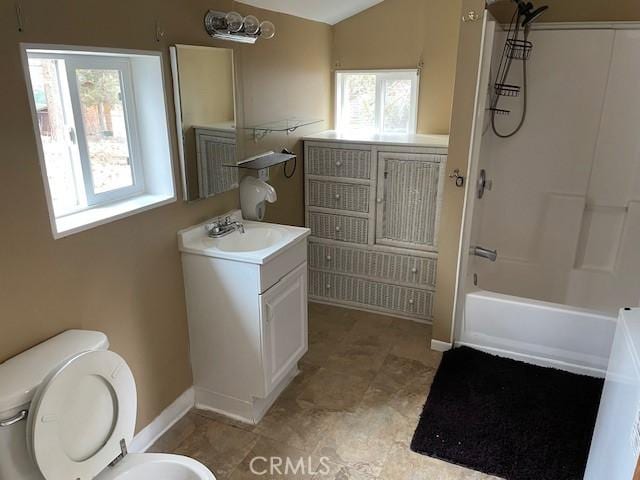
[469,25,640,315]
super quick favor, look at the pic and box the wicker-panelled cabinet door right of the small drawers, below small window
[376,152,447,251]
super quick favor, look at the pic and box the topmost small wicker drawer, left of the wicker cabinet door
[306,146,371,179]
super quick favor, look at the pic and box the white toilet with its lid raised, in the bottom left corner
[0,330,215,480]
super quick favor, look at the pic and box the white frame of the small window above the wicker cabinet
[334,68,421,135]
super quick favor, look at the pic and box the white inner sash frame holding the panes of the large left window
[26,50,145,211]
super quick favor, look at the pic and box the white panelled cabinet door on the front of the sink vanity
[260,262,308,395]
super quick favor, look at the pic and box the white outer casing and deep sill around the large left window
[19,42,177,240]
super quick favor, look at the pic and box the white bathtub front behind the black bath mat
[455,290,616,377]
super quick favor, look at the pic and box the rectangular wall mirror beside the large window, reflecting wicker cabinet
[170,45,239,201]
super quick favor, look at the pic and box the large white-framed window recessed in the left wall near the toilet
[24,48,175,237]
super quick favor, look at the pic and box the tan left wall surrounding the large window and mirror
[0,0,331,428]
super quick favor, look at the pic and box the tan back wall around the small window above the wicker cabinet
[333,0,461,134]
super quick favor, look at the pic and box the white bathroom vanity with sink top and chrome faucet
[178,212,310,424]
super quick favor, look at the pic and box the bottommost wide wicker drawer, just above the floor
[309,270,433,319]
